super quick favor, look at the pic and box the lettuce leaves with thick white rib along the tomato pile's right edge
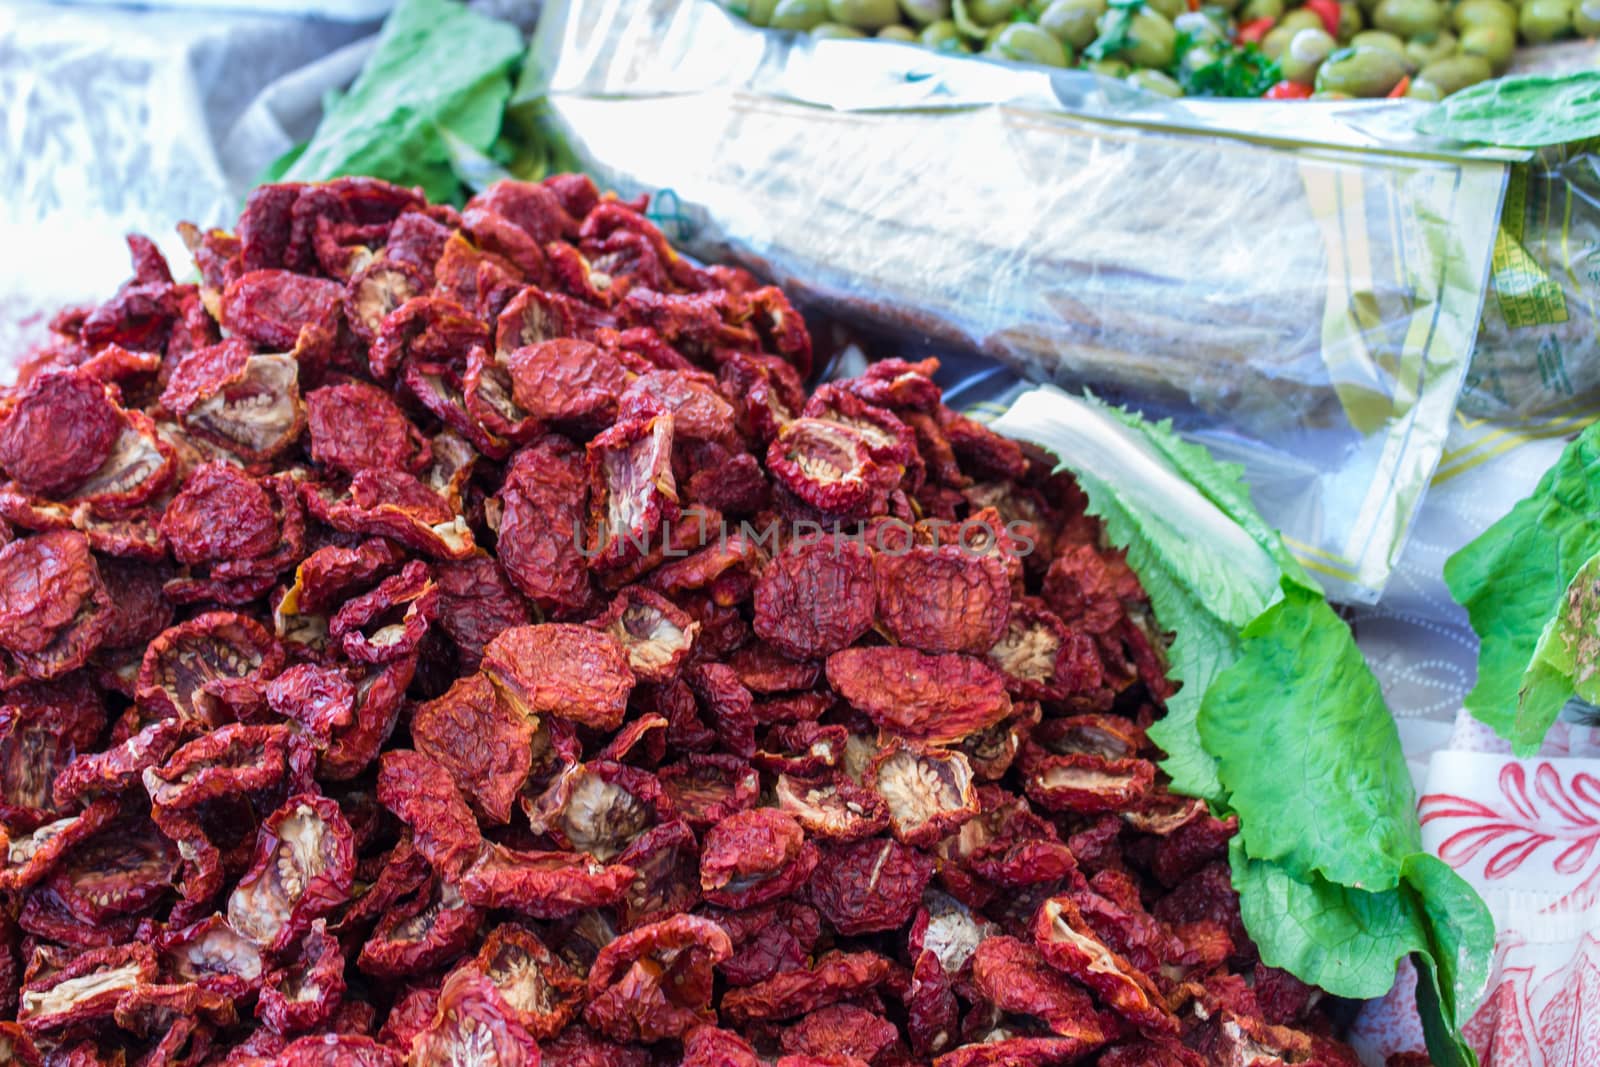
[994,389,1494,1067]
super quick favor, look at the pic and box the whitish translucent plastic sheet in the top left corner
[0,3,373,381]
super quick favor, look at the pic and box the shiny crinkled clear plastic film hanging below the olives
[522,0,1515,601]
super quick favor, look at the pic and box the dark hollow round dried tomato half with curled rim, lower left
[136,611,286,725]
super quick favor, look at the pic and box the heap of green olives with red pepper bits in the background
[725,0,1600,99]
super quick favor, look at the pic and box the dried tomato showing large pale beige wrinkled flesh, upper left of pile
[162,338,306,462]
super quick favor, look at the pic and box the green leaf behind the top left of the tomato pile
[283,0,523,202]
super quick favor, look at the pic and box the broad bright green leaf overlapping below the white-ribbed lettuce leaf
[1198,585,1422,891]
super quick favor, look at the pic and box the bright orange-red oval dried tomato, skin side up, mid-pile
[483,622,634,729]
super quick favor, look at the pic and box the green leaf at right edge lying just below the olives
[1416,70,1600,149]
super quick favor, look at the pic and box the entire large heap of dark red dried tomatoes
[0,176,1355,1067]
